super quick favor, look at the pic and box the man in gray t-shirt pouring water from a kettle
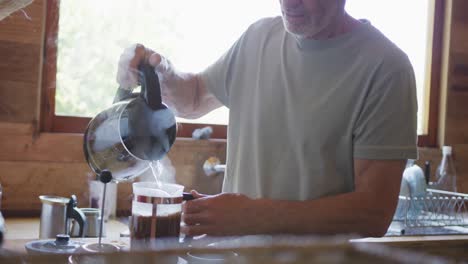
[118,0,417,236]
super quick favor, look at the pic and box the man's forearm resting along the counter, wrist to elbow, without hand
[254,192,396,236]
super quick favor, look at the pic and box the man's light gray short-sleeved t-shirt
[201,17,417,200]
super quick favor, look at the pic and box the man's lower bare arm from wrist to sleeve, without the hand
[254,160,405,236]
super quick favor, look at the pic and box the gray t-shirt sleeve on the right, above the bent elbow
[353,66,418,159]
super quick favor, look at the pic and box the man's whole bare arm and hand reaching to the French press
[183,160,405,237]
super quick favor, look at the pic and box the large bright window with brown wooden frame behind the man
[43,0,442,145]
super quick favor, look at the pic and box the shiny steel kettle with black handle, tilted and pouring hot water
[84,64,177,181]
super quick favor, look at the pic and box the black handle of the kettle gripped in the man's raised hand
[138,64,162,111]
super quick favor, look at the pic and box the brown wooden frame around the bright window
[40,0,445,147]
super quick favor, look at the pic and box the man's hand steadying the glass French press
[181,191,260,236]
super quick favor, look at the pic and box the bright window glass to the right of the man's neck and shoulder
[347,0,432,135]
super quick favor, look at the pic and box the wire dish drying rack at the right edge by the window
[393,189,468,228]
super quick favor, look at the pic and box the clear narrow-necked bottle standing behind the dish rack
[434,146,457,192]
